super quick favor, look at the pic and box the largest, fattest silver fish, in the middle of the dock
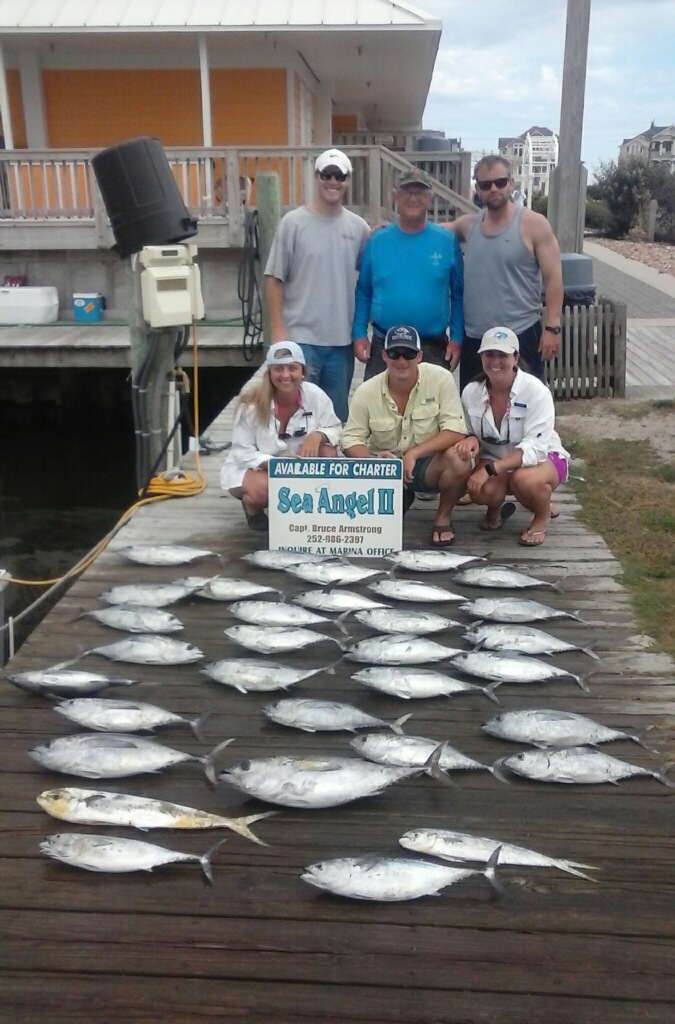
[207,740,442,808]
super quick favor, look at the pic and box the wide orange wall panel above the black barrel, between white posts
[43,70,202,148]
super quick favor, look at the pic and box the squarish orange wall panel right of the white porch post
[211,68,289,146]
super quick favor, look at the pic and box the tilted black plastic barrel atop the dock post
[91,138,197,256]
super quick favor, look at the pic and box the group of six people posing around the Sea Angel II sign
[221,148,569,547]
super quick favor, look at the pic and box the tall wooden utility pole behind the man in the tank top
[549,0,591,253]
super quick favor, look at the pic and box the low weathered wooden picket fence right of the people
[543,297,626,399]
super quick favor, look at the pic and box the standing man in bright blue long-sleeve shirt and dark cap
[351,169,464,380]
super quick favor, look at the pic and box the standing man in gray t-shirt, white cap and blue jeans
[265,150,370,423]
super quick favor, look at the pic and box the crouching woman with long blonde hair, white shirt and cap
[220,341,342,532]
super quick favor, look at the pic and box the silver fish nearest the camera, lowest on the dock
[300,850,503,903]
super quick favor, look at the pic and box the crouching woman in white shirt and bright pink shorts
[456,327,569,548]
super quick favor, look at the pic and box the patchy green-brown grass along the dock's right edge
[561,430,675,657]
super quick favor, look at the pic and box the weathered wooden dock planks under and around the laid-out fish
[0,389,675,1024]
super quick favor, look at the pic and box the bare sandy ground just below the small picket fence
[555,398,675,464]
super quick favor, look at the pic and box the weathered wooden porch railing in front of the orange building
[0,145,473,249]
